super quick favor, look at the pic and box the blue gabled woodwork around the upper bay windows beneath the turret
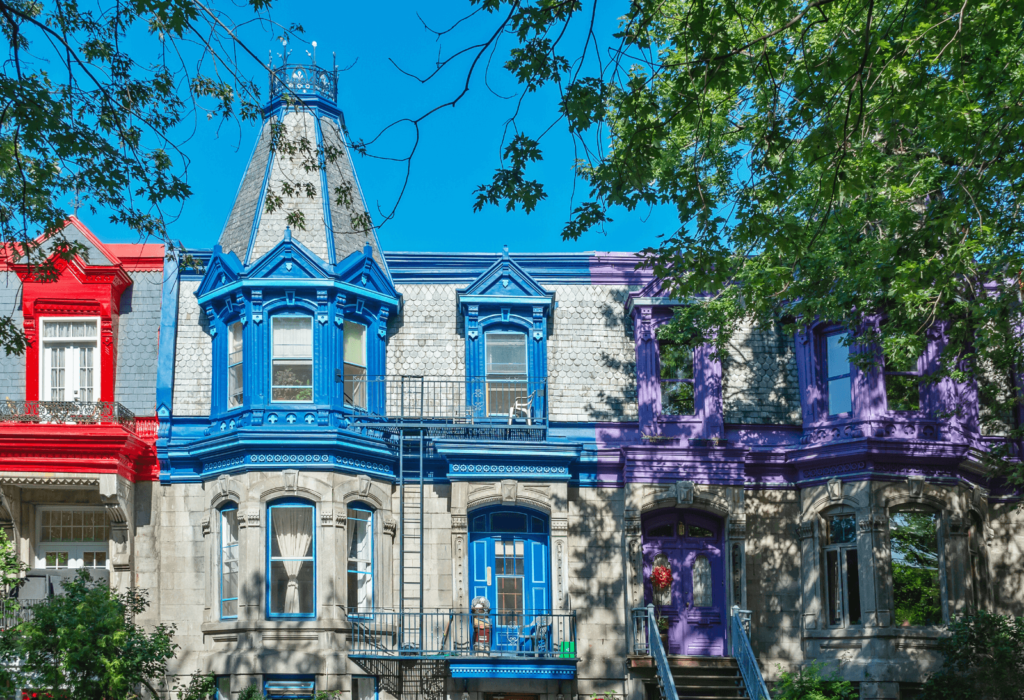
[196,230,399,426]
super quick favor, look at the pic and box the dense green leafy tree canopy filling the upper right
[454,0,1024,474]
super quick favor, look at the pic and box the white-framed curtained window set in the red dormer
[40,318,99,402]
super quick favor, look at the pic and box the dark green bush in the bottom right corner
[918,610,1024,700]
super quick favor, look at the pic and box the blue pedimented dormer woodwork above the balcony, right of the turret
[457,247,555,418]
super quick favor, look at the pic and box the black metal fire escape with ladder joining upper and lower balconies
[346,377,547,700]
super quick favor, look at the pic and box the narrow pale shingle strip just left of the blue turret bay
[172,279,213,415]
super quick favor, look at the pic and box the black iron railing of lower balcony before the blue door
[348,610,577,660]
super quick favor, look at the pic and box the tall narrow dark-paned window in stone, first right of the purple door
[822,510,864,627]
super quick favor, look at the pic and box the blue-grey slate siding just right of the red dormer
[114,270,163,415]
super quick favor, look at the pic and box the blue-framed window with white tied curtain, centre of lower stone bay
[266,498,316,617]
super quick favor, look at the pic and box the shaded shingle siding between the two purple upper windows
[722,325,802,425]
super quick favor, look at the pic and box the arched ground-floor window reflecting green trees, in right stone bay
[889,507,943,626]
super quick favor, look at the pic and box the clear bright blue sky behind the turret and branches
[81,0,678,252]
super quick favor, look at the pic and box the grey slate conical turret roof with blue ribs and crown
[219,65,387,271]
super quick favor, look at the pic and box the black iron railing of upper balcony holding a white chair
[344,375,548,427]
